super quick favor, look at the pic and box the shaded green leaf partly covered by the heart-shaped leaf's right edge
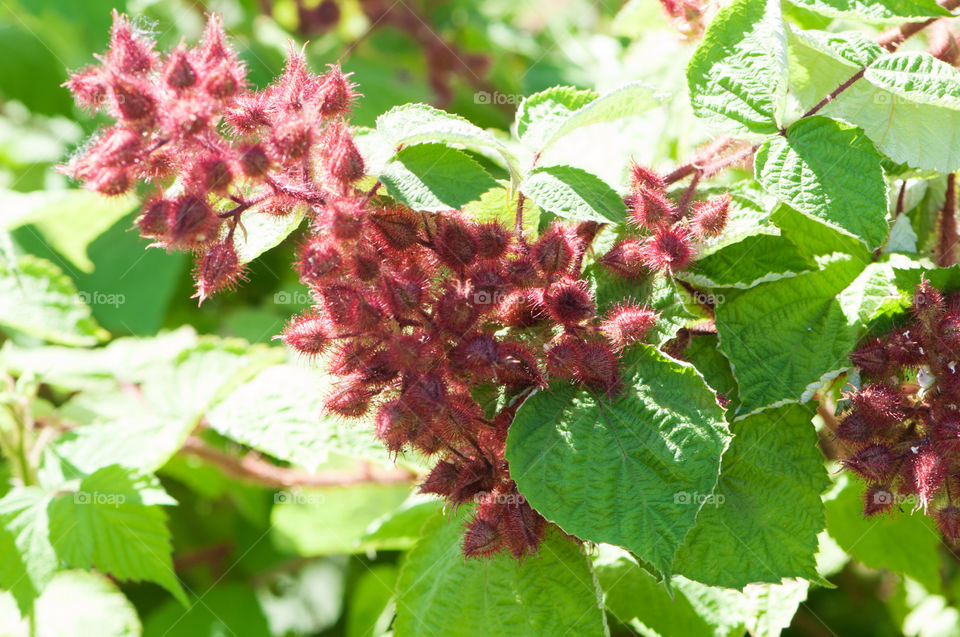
[675,405,830,588]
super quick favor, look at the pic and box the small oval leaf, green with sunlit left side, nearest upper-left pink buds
[380,144,497,211]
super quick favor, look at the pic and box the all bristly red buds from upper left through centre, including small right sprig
[66,9,729,558]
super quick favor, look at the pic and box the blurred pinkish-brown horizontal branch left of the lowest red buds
[180,436,416,489]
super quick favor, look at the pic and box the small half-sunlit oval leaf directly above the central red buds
[520,166,627,224]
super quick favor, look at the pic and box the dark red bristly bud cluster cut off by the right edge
[835,281,960,541]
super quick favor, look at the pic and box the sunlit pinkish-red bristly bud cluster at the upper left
[62,12,364,302]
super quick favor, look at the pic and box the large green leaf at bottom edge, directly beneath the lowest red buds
[394,513,606,637]
